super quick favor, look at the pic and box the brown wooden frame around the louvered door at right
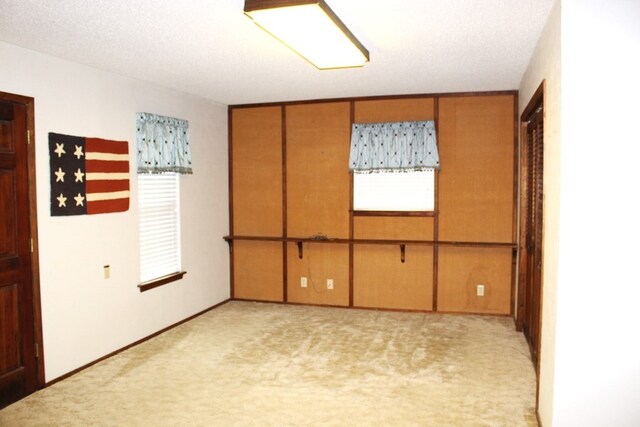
[516,80,545,372]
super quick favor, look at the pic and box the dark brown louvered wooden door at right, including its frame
[517,86,544,369]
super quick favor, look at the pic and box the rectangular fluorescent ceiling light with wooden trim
[244,0,369,70]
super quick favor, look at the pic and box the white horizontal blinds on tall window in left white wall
[138,173,181,282]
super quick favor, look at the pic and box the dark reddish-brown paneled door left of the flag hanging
[0,93,43,408]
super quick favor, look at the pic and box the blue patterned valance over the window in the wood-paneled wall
[349,120,440,173]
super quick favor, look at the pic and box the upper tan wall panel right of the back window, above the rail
[438,95,514,242]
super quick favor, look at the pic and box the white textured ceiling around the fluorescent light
[0,0,554,104]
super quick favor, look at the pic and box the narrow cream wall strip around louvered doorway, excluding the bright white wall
[519,2,560,426]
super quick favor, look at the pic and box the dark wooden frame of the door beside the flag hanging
[0,92,45,392]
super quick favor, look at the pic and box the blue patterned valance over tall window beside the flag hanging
[136,113,193,174]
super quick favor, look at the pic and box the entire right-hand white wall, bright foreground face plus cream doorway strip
[520,0,640,427]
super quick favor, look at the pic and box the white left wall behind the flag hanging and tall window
[0,43,229,381]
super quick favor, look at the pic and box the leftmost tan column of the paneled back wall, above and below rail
[229,107,284,301]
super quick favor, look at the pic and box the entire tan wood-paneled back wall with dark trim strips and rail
[229,92,517,314]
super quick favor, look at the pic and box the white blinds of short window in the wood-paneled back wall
[353,169,435,211]
